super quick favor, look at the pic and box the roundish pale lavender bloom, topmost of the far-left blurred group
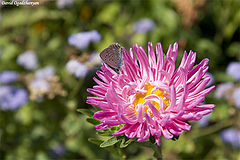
[17,51,38,70]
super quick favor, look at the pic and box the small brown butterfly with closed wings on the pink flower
[100,43,123,70]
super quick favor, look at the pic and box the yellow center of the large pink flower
[133,83,170,113]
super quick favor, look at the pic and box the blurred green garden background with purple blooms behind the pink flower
[0,0,240,160]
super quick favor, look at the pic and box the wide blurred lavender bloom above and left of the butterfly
[68,30,101,49]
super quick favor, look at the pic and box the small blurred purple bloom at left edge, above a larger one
[0,70,18,84]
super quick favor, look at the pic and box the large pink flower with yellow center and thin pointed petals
[87,43,215,145]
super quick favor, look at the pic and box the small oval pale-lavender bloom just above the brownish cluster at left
[35,66,55,79]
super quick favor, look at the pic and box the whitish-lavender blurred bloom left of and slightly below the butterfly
[66,60,88,78]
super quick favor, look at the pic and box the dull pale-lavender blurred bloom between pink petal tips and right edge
[215,82,234,99]
